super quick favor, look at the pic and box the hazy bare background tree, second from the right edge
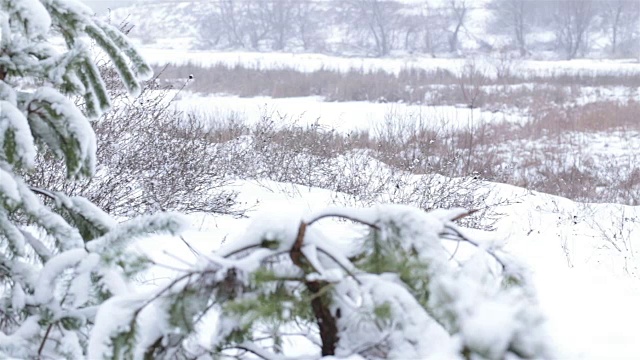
[552,0,595,59]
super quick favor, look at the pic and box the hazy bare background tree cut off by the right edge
[598,0,640,55]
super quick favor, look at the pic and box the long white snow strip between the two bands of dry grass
[174,95,525,134]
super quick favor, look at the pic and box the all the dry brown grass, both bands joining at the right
[154,63,640,204]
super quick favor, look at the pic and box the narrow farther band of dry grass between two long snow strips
[158,62,640,109]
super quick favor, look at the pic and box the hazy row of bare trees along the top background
[199,0,640,59]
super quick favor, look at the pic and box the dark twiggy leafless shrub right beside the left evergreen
[28,65,243,216]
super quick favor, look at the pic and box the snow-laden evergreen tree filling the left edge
[0,0,184,359]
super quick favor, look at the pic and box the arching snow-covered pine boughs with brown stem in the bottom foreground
[95,205,553,359]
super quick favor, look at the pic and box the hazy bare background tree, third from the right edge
[490,0,544,56]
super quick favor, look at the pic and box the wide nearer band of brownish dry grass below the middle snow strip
[191,95,640,205]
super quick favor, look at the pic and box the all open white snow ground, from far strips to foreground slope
[125,43,640,359]
